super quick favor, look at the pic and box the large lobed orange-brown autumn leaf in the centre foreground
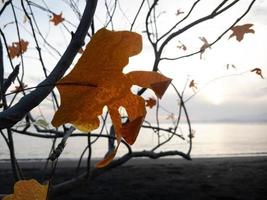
[52,28,171,167]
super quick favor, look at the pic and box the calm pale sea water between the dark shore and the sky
[0,123,267,159]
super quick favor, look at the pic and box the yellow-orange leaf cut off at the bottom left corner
[3,179,48,200]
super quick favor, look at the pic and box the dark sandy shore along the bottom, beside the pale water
[0,157,267,200]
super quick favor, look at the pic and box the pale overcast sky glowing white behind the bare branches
[0,0,267,122]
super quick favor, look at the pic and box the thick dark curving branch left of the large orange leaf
[0,0,97,129]
